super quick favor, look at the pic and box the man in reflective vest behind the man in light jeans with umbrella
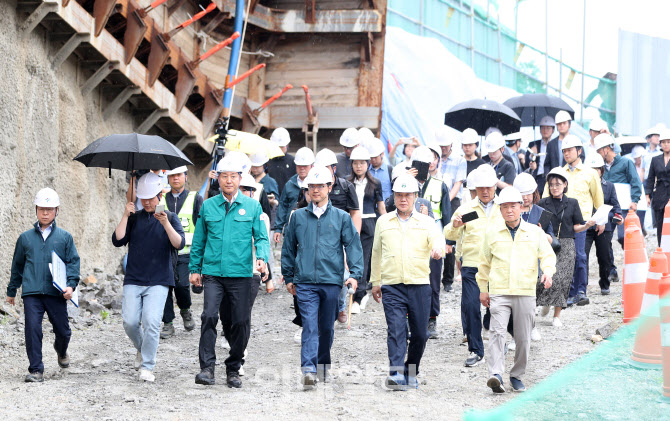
[160,166,203,339]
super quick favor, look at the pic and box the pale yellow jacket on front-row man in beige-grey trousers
[476,220,556,297]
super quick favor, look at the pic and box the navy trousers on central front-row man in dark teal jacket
[295,284,341,373]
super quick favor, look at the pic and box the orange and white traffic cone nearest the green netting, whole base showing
[631,248,668,368]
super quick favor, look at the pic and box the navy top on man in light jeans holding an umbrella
[112,209,186,286]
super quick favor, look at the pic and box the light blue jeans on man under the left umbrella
[121,285,168,371]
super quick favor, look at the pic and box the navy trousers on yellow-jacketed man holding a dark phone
[461,266,484,357]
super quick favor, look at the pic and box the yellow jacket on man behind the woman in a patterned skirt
[542,163,605,221]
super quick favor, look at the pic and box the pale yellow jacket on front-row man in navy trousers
[370,211,445,286]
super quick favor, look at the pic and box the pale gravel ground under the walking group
[0,236,656,420]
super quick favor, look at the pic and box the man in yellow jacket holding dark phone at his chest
[444,164,502,367]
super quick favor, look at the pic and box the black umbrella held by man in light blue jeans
[74,133,193,177]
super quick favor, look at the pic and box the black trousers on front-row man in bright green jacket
[199,275,251,373]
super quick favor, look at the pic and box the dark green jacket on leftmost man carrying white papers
[7,221,79,297]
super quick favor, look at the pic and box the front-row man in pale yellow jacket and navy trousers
[370,174,445,390]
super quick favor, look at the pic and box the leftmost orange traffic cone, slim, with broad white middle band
[622,226,652,323]
